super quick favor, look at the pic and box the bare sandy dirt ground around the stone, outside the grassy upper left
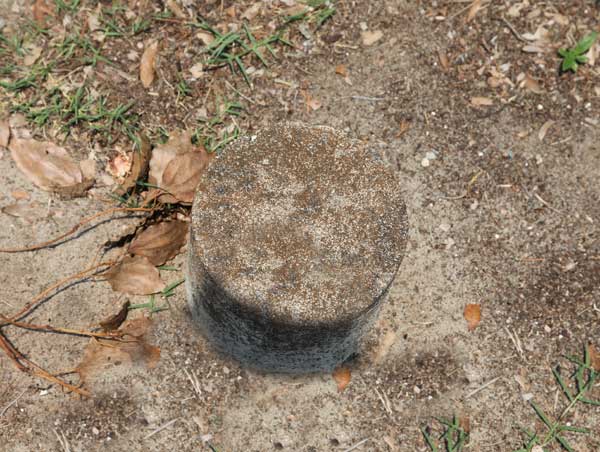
[0,0,600,452]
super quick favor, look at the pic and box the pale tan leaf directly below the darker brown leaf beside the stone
[105,256,165,295]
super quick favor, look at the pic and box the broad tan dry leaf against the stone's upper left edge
[160,149,210,203]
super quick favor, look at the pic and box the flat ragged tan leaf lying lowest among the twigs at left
[76,317,160,382]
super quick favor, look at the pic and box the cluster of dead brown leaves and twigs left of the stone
[0,115,216,395]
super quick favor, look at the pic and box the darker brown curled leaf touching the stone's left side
[128,221,188,265]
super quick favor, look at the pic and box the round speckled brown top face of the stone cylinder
[191,123,407,326]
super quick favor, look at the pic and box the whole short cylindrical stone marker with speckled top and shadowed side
[186,123,407,372]
